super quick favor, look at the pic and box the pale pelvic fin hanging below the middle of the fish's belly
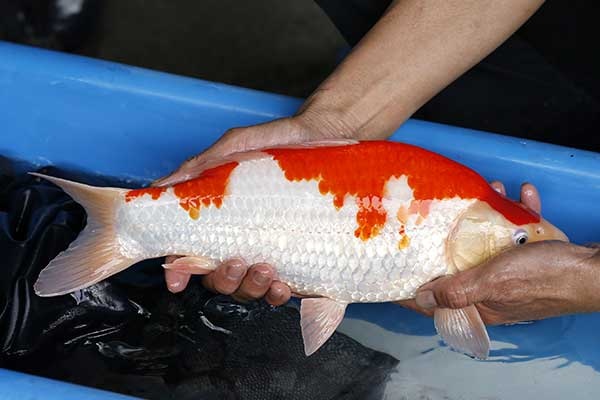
[300,297,347,356]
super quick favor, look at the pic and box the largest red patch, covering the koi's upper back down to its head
[264,141,540,240]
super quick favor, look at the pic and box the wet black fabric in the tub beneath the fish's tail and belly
[0,163,398,399]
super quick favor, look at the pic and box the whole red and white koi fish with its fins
[34,141,568,359]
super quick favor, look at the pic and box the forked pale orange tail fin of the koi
[31,173,139,297]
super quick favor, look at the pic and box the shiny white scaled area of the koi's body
[117,158,472,302]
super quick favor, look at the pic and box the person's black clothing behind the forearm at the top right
[316,0,600,151]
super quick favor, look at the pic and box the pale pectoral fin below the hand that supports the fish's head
[434,306,490,360]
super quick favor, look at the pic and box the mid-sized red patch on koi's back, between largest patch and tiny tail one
[173,161,238,219]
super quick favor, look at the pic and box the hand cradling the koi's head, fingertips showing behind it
[400,183,600,324]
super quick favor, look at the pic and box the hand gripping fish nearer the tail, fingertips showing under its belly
[154,112,353,305]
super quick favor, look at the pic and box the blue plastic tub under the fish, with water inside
[0,42,600,399]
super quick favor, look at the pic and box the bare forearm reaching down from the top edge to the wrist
[300,0,543,139]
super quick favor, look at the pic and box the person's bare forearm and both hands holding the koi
[161,0,600,334]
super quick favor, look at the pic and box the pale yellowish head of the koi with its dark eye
[446,199,569,273]
